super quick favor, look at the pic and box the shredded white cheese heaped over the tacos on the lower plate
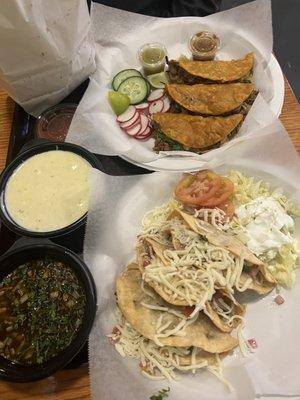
[140,209,252,323]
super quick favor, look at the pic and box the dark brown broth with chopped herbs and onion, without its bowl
[0,259,86,365]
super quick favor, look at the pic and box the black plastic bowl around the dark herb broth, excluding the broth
[0,244,97,382]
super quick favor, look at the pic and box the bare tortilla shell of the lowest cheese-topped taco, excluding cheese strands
[117,268,238,353]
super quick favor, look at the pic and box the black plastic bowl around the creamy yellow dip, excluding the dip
[0,141,100,238]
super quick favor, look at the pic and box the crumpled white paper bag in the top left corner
[0,0,96,116]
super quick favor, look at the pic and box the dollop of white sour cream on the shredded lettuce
[235,197,294,255]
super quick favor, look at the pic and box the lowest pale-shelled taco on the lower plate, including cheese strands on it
[117,268,238,353]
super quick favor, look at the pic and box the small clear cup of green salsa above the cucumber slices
[138,43,167,75]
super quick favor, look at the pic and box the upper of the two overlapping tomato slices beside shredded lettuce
[175,171,222,206]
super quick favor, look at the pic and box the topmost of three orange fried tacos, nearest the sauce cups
[168,53,254,85]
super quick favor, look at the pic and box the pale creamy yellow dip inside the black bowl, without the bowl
[5,150,91,232]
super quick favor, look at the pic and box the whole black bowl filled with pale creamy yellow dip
[0,141,100,238]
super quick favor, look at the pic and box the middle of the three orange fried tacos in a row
[166,83,257,116]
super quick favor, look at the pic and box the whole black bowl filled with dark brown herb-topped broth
[0,244,97,382]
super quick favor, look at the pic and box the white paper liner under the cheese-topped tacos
[84,116,300,400]
